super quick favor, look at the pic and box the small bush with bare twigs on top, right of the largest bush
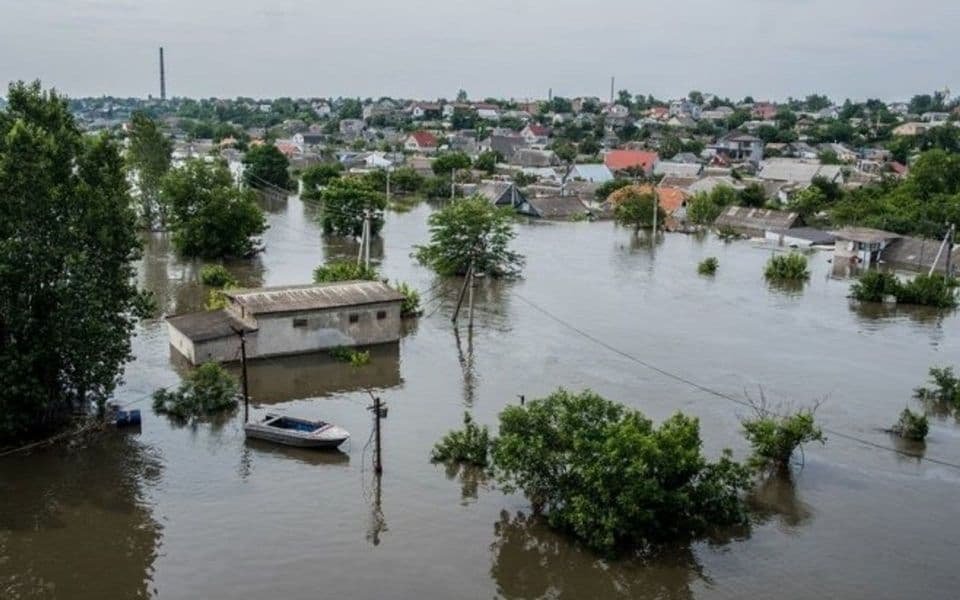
[742,408,826,471]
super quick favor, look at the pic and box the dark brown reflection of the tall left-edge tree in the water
[0,433,161,600]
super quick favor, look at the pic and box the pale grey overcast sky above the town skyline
[0,0,960,100]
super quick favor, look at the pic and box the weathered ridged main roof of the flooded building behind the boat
[224,281,403,315]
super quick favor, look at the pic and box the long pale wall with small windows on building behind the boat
[247,302,401,358]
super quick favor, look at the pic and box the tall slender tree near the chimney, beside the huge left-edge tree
[127,111,173,229]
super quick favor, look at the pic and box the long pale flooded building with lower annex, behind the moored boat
[167,281,403,365]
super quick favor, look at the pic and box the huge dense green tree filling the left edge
[0,82,149,445]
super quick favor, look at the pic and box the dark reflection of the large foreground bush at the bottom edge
[490,512,705,599]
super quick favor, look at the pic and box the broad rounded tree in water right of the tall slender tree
[161,159,267,258]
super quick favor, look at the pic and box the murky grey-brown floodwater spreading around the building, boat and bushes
[0,198,960,600]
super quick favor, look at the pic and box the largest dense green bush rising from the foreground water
[493,390,750,553]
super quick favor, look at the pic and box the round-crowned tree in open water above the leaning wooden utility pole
[414,196,524,277]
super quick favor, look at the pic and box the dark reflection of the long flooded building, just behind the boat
[227,343,403,404]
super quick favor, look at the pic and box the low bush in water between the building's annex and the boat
[153,363,237,419]
